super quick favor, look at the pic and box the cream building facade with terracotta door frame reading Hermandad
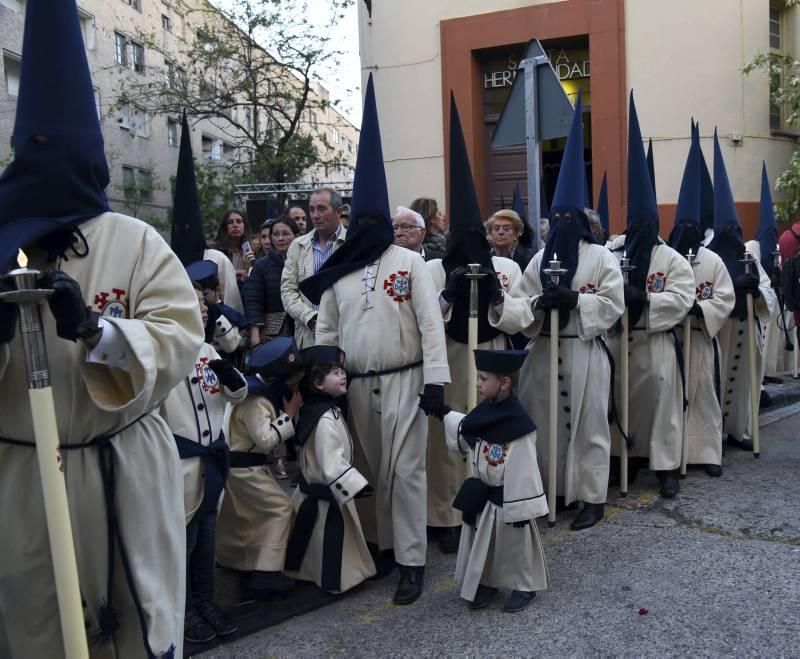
[359,0,800,237]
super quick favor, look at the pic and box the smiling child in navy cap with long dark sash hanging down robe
[284,346,375,593]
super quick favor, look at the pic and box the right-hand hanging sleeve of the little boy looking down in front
[503,431,548,524]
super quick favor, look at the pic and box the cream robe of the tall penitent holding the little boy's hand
[316,245,450,565]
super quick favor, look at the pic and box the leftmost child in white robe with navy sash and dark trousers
[160,282,247,643]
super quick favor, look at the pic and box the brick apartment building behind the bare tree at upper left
[0,0,358,228]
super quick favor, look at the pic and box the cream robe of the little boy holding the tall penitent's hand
[444,412,550,602]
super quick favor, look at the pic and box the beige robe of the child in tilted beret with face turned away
[217,395,294,572]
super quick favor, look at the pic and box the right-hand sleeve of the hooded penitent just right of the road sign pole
[576,249,625,341]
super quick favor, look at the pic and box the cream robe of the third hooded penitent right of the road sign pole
[677,246,736,465]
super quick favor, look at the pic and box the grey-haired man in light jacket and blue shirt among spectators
[281,188,347,349]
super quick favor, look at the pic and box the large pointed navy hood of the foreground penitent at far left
[0,0,110,272]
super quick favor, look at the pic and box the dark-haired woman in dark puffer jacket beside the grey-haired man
[243,216,300,347]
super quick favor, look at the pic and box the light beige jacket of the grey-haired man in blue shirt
[281,227,347,350]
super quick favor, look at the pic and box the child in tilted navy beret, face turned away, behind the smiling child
[217,336,304,596]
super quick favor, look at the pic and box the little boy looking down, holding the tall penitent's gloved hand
[444,350,549,613]
